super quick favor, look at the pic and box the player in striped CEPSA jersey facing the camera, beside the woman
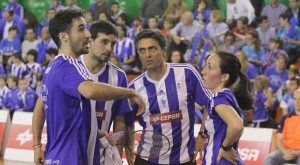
[129,29,211,165]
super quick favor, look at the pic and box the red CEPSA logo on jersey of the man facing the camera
[150,110,182,125]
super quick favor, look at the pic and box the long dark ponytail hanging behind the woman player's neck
[233,71,255,110]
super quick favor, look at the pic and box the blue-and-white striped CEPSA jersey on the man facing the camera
[129,63,211,164]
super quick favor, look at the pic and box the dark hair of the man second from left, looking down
[90,20,118,40]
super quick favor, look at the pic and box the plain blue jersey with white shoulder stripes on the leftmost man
[42,54,99,165]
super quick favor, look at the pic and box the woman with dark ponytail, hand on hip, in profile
[202,52,254,165]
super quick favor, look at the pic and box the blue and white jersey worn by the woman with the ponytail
[202,88,244,165]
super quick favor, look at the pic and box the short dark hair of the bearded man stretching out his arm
[49,9,83,48]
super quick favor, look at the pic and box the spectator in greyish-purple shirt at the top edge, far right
[261,0,287,29]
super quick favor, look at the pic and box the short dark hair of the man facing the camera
[135,29,166,48]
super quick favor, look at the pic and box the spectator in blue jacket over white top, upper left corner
[0,9,25,40]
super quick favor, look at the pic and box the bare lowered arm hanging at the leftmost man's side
[32,97,46,165]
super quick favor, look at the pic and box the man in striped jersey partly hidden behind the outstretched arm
[80,21,133,164]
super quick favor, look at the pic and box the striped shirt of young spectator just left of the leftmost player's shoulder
[25,62,41,89]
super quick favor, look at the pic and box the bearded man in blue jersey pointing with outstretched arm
[32,9,145,165]
